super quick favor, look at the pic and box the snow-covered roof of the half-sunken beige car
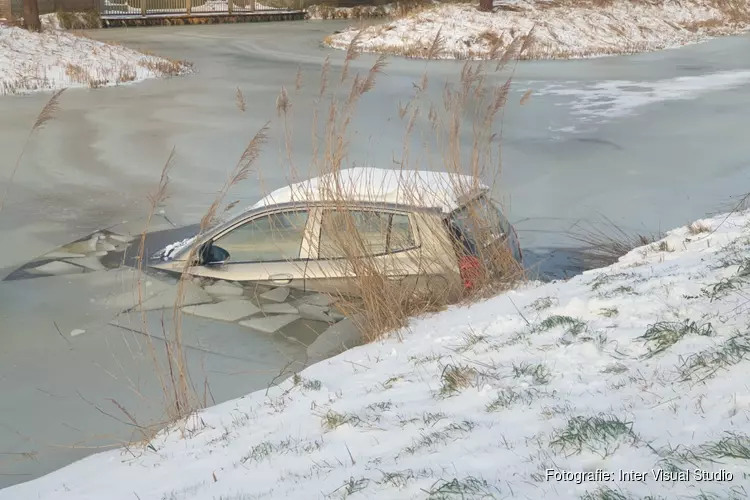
[250,167,489,214]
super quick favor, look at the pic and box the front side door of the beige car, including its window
[189,208,311,290]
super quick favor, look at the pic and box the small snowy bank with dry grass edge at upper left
[0,26,190,95]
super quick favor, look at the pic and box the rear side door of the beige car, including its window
[305,207,420,295]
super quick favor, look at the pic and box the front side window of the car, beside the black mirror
[214,210,308,262]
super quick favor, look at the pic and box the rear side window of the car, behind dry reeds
[318,210,415,259]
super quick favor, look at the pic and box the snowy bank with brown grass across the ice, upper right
[325,0,750,59]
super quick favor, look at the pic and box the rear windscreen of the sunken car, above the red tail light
[447,196,511,255]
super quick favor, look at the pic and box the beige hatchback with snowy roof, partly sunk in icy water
[148,168,522,294]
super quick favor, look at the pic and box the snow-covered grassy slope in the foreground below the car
[0,205,750,500]
